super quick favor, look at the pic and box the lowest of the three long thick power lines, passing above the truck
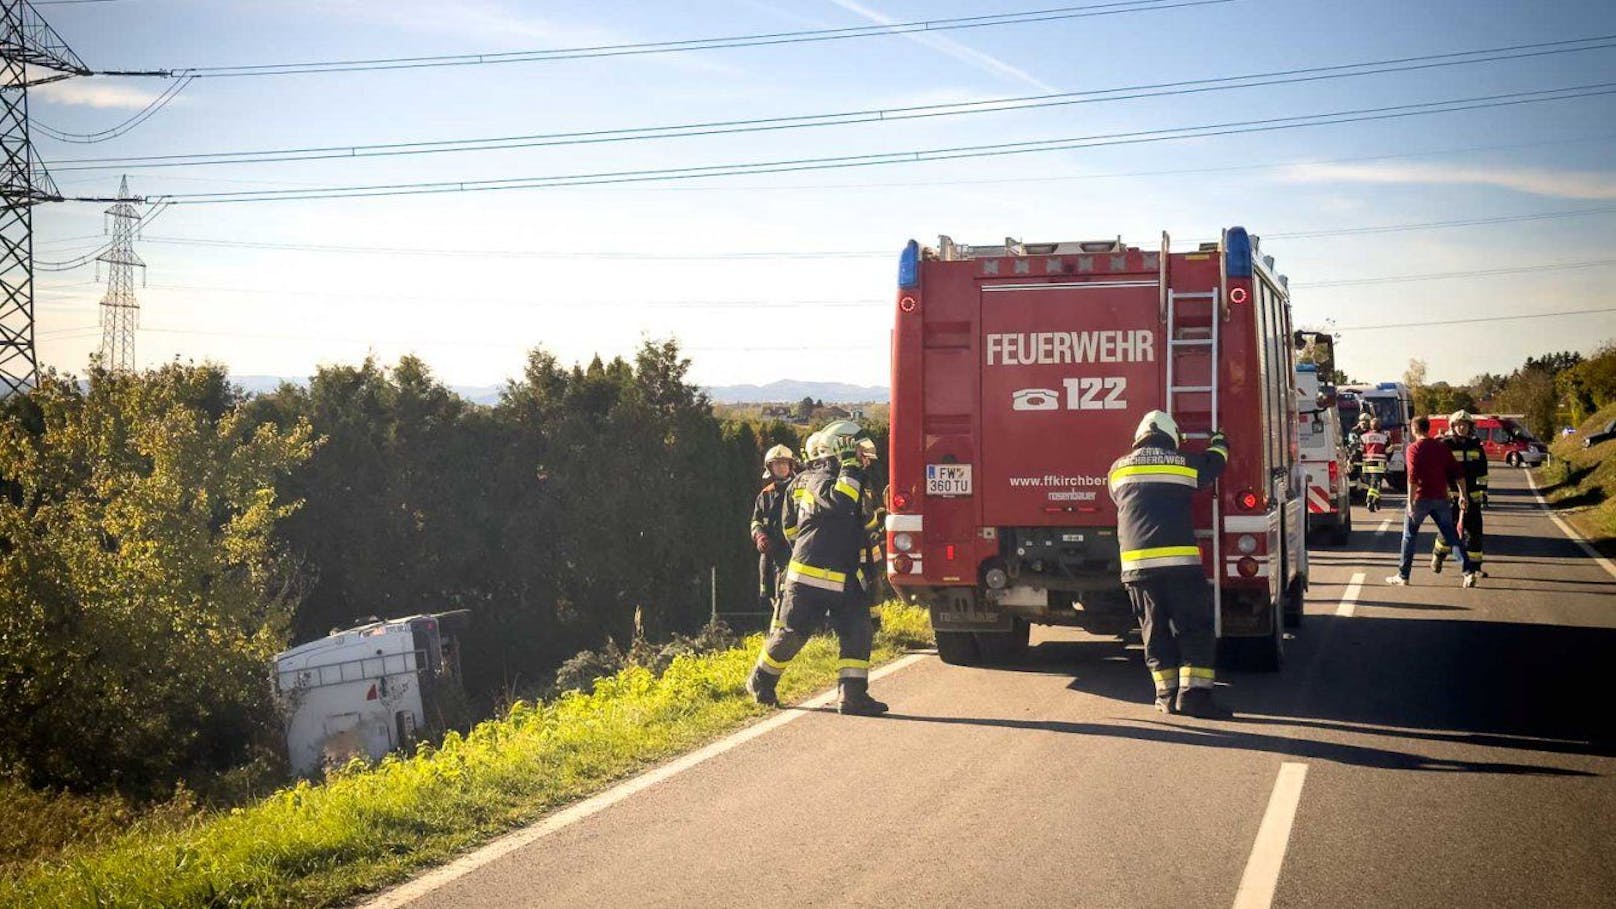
[142,82,1616,205]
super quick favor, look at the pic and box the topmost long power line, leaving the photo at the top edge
[164,0,1233,78]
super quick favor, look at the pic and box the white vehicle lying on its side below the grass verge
[275,610,467,776]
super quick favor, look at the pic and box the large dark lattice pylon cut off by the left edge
[0,0,90,396]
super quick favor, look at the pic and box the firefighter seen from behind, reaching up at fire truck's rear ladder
[1107,411,1230,718]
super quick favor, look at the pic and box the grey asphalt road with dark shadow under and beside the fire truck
[381,469,1616,909]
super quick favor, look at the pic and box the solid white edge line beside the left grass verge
[360,653,928,909]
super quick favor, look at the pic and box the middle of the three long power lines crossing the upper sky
[53,34,1616,171]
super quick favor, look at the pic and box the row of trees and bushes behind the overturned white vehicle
[0,341,884,794]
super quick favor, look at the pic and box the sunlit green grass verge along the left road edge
[0,605,931,909]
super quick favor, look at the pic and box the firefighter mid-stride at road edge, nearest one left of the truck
[747,421,887,717]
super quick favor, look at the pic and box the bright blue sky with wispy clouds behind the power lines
[32,0,1616,383]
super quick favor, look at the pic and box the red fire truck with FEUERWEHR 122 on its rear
[887,228,1307,670]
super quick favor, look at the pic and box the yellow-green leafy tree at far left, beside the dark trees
[0,364,315,794]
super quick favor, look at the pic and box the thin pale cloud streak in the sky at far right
[1281,163,1616,201]
